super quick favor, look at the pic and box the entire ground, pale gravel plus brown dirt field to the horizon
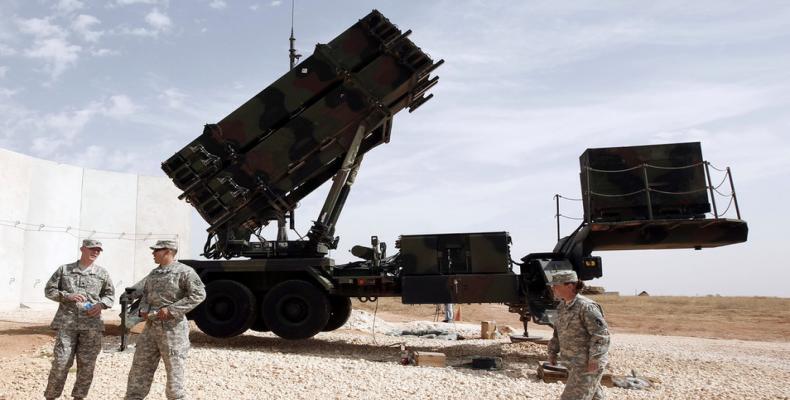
[0,296,790,400]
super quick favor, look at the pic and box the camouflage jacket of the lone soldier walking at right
[548,295,609,366]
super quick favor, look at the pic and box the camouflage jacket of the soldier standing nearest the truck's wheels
[133,262,206,332]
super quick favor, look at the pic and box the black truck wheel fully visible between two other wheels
[263,280,329,339]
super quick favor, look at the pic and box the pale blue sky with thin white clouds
[0,0,790,296]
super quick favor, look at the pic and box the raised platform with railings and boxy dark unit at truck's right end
[555,142,749,254]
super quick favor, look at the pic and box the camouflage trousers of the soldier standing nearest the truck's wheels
[124,321,189,400]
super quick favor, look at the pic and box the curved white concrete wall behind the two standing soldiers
[0,149,192,309]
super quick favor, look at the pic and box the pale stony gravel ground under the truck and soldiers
[0,310,790,400]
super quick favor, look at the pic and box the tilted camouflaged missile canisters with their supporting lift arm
[162,10,443,258]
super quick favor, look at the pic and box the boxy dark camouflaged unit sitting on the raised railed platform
[579,142,710,222]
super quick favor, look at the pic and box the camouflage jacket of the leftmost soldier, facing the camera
[44,261,115,331]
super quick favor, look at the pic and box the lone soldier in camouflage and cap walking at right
[549,271,609,400]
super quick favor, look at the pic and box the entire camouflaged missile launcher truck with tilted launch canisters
[148,10,748,339]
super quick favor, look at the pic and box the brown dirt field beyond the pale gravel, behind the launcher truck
[354,295,790,342]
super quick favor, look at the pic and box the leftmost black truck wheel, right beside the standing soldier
[194,280,257,338]
